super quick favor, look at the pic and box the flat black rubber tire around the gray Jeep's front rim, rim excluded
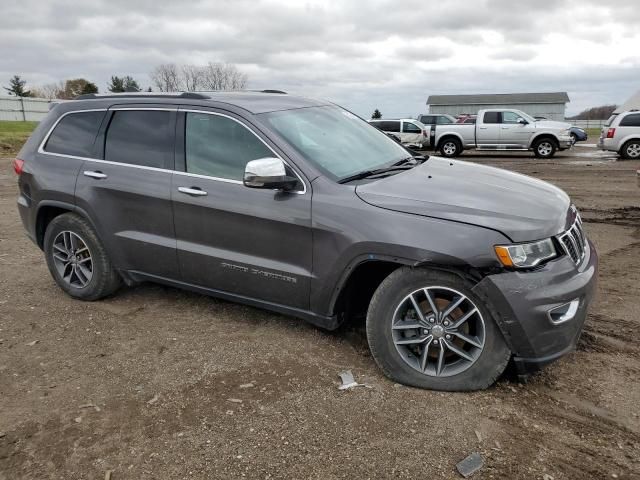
[367,267,511,391]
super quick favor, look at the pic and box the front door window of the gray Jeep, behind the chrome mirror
[185,113,274,180]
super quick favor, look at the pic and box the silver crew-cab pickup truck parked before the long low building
[430,109,572,158]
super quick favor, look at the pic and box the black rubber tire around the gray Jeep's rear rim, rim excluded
[44,213,122,301]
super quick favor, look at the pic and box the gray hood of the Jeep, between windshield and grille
[356,157,575,242]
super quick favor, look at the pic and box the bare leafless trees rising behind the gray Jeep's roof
[149,62,247,92]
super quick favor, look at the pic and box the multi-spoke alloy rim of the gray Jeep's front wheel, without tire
[391,287,486,377]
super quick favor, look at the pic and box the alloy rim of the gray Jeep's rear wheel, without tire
[52,231,93,288]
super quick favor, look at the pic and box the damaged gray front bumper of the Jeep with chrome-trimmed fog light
[474,241,598,374]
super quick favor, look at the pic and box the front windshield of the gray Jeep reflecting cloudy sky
[259,106,410,180]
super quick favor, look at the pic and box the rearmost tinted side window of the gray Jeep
[45,112,105,157]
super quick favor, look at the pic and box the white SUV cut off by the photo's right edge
[598,110,640,160]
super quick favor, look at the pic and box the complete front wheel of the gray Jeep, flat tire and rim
[367,267,511,391]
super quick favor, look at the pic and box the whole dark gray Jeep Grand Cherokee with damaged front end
[14,92,597,390]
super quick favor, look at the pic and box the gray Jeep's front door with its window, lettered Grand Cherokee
[171,111,312,309]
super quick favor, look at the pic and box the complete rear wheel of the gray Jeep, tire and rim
[44,213,121,300]
